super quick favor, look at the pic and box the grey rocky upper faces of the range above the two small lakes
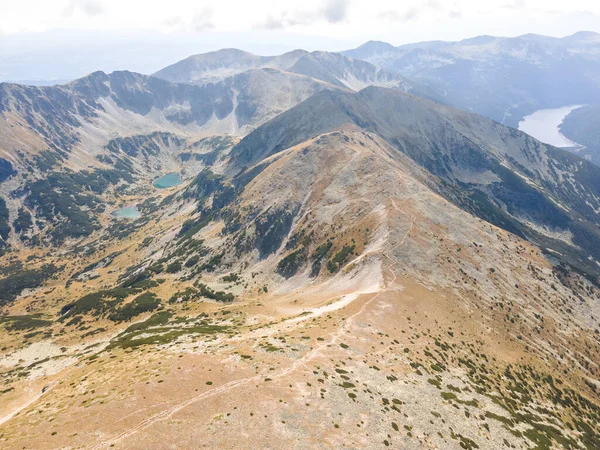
[0,69,333,150]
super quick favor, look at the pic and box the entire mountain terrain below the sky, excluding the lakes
[0,29,600,449]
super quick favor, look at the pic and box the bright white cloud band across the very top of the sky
[0,0,600,43]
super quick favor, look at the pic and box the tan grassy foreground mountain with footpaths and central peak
[0,125,600,449]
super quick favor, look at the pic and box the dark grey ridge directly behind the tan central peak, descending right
[230,87,600,276]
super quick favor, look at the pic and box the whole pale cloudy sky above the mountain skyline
[0,0,600,81]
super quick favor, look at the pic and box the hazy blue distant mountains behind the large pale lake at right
[344,33,600,127]
